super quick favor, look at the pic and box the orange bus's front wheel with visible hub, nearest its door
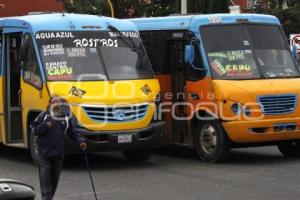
[195,120,231,163]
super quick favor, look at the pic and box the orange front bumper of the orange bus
[222,117,300,143]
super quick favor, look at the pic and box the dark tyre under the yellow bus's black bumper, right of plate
[123,149,153,163]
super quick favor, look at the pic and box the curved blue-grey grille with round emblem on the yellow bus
[82,104,148,122]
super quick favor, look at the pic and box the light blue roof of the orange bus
[130,14,280,31]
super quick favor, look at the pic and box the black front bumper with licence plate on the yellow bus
[66,121,166,153]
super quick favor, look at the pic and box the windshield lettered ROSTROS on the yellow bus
[35,31,153,81]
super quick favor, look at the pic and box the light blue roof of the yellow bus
[0,13,137,34]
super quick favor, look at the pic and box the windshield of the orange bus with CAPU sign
[201,24,300,79]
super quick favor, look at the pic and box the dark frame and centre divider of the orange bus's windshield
[198,21,300,81]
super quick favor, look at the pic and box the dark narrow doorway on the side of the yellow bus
[3,32,24,145]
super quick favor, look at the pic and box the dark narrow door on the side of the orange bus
[167,39,187,143]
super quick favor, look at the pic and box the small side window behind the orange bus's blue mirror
[188,46,206,81]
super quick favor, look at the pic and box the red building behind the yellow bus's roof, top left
[0,0,64,17]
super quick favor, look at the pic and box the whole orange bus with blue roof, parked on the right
[130,14,300,162]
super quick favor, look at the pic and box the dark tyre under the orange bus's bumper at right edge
[277,141,300,157]
